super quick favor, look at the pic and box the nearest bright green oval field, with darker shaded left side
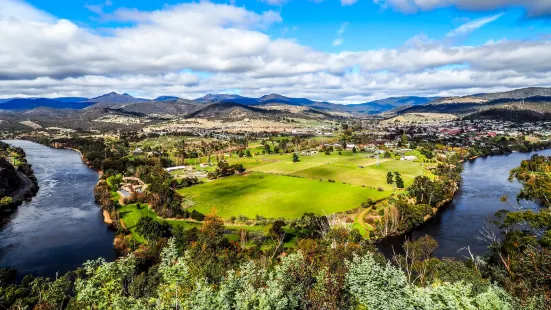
[178,172,391,219]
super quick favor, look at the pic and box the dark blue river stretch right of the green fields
[378,150,551,258]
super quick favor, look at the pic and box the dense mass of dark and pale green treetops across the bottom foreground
[0,216,517,310]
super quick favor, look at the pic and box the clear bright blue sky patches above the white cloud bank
[23,0,551,52]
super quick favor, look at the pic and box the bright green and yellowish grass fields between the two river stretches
[117,139,426,246]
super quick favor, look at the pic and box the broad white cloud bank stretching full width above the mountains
[0,0,551,103]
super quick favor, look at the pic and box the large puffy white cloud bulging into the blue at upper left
[0,3,286,79]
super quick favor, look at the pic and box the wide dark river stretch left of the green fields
[0,140,116,277]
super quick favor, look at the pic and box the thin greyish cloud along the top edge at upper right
[373,0,551,17]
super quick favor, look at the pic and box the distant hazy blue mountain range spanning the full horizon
[0,87,551,119]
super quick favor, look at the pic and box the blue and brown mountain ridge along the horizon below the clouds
[0,87,551,117]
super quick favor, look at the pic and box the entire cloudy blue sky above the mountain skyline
[0,0,551,103]
